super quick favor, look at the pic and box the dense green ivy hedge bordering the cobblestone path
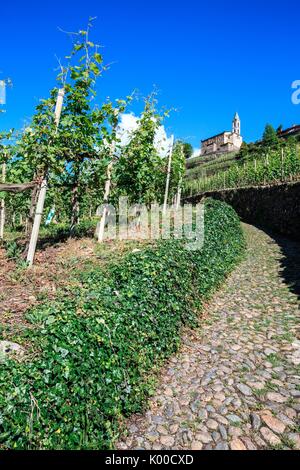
[0,200,244,449]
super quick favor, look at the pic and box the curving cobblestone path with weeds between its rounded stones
[116,225,300,450]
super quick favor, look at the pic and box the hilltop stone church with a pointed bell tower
[201,113,243,155]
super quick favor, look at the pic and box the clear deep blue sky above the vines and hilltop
[0,0,300,147]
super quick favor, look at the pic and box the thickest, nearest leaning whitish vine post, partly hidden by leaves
[27,88,65,267]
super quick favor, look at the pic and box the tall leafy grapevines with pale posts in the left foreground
[0,22,185,266]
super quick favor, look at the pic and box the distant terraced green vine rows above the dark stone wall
[185,142,300,196]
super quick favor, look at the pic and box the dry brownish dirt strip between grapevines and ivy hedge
[0,238,148,326]
